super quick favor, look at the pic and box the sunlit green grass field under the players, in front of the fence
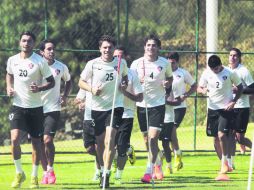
[0,152,254,190]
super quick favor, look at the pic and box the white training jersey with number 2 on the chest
[199,67,241,110]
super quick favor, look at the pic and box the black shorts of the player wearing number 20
[9,106,44,138]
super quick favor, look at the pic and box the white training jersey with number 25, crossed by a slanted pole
[80,57,128,111]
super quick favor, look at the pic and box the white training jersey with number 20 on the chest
[6,53,52,108]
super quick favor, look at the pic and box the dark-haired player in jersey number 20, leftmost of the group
[6,31,55,188]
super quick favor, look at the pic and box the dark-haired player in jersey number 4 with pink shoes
[131,34,173,183]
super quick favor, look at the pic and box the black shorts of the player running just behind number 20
[44,111,60,137]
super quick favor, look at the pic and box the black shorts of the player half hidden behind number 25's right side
[115,118,133,148]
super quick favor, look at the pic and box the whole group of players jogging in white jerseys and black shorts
[6,31,254,188]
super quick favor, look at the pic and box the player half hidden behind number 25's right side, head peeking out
[114,46,143,183]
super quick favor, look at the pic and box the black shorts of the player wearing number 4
[137,105,165,133]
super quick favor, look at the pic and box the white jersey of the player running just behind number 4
[172,67,195,108]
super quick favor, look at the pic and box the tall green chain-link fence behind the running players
[0,0,254,153]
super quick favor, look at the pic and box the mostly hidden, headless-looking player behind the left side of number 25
[74,89,101,181]
